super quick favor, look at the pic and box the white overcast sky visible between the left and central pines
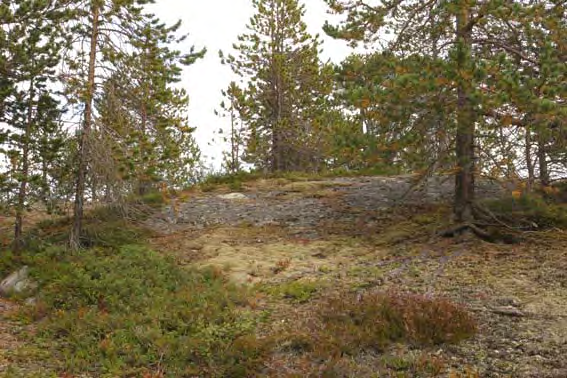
[146,0,356,168]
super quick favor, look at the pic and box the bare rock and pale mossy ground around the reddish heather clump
[0,176,567,378]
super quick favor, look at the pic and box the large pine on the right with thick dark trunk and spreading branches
[325,0,564,224]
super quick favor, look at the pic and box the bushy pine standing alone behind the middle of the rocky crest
[221,0,332,171]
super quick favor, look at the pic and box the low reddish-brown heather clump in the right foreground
[283,292,476,358]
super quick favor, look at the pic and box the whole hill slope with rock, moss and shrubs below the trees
[0,176,567,378]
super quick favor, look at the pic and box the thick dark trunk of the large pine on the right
[454,2,475,222]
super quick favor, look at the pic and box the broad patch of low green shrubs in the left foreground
[22,246,265,377]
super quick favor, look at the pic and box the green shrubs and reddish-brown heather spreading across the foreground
[0,195,482,377]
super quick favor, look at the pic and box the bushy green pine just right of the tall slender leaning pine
[97,17,205,195]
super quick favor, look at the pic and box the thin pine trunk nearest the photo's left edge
[14,78,35,254]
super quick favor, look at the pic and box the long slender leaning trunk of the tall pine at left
[69,3,100,250]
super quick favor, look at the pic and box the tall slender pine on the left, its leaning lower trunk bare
[65,0,169,249]
